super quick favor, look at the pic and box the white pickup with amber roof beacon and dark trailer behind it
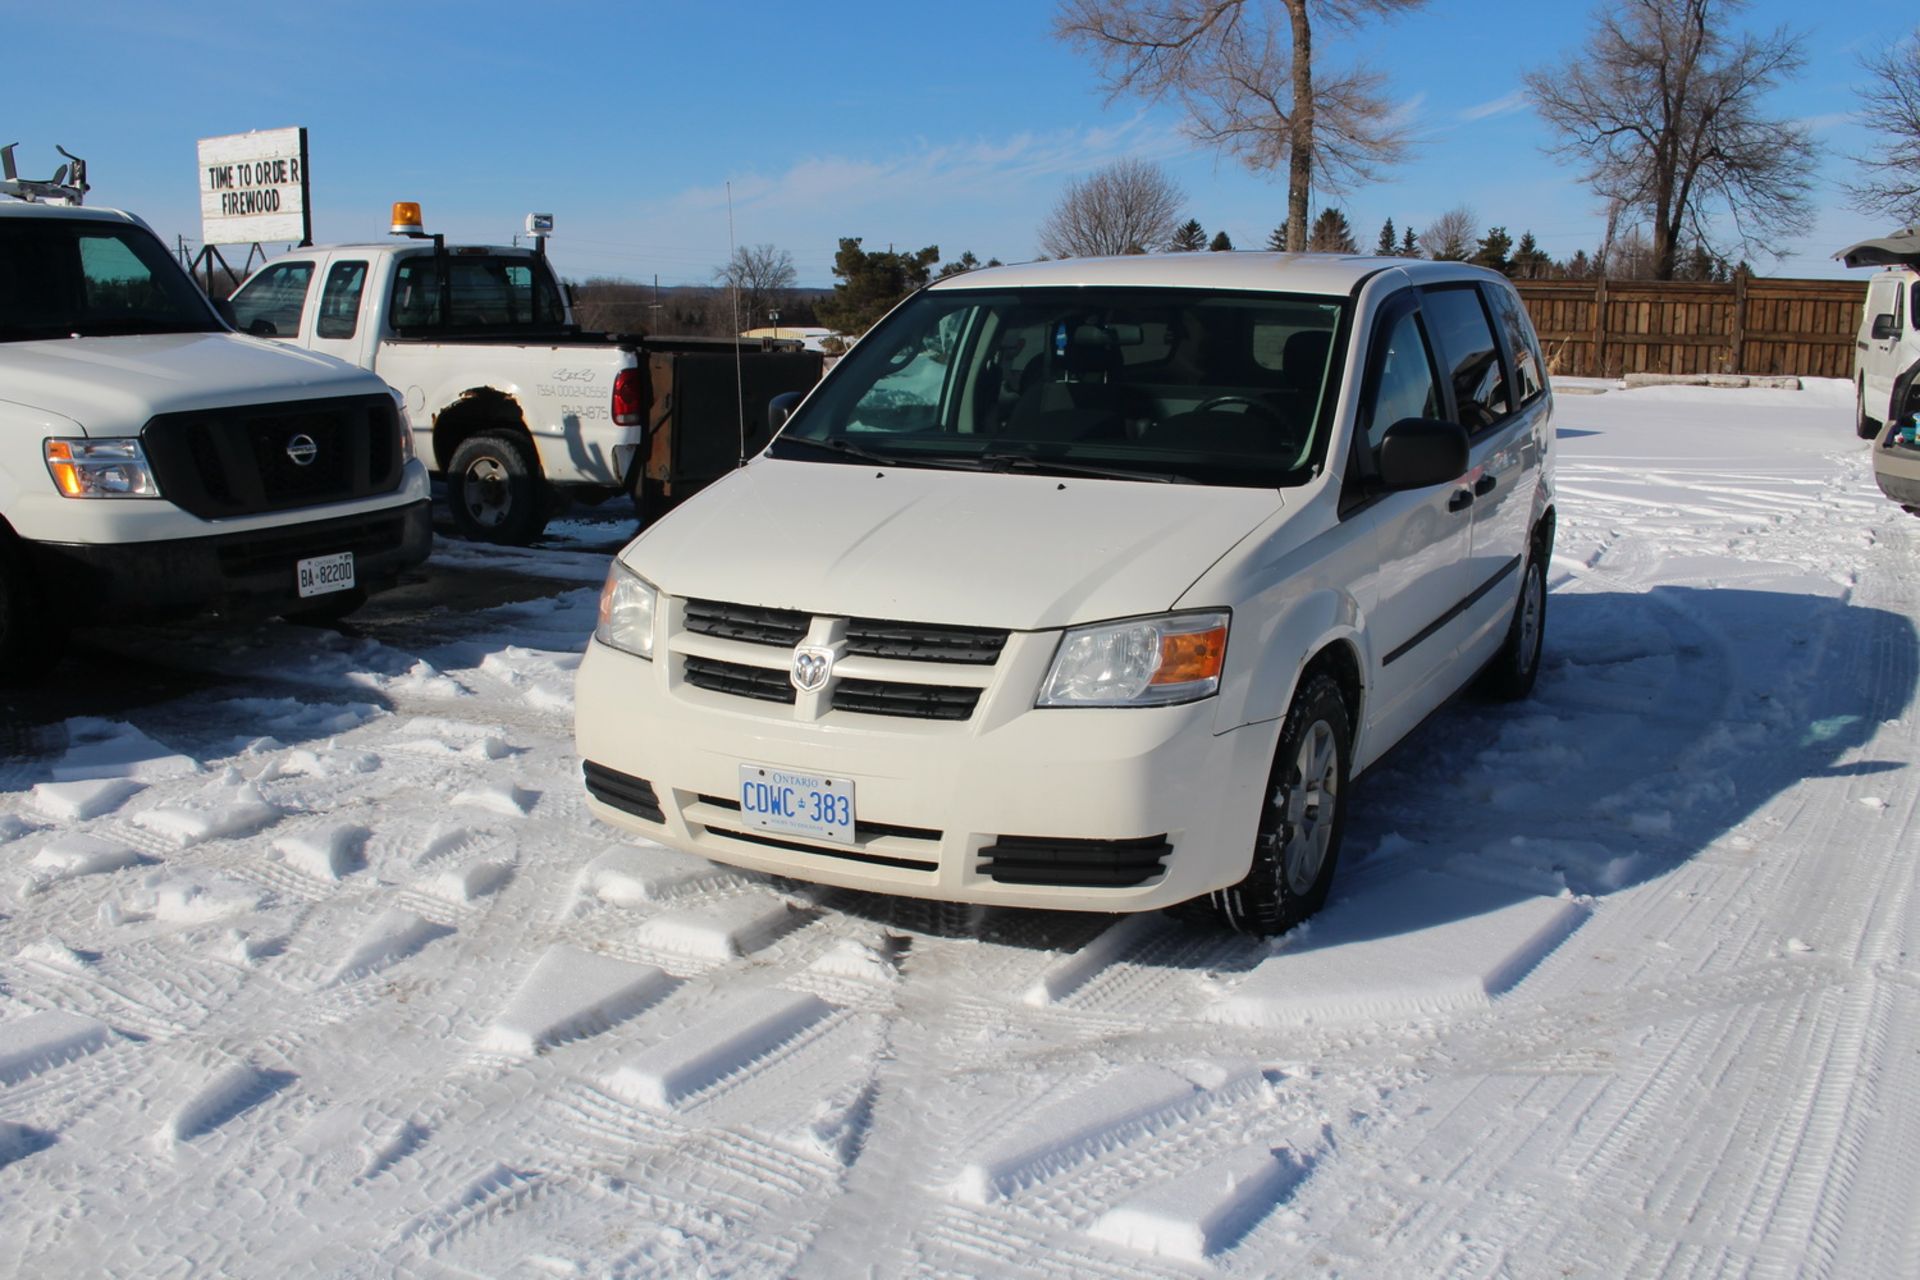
[232,225,820,545]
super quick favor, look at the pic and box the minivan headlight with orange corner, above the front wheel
[1035,612,1229,706]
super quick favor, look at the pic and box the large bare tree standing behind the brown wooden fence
[1526,0,1814,280]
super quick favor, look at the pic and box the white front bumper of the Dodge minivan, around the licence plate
[574,635,1279,912]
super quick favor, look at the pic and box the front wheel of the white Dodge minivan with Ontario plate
[1210,674,1354,936]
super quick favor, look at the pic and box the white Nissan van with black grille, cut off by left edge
[0,197,432,681]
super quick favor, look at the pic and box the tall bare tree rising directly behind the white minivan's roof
[1054,0,1425,244]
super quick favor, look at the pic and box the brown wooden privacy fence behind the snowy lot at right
[1513,274,1866,378]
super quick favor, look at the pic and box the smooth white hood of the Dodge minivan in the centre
[622,457,1281,631]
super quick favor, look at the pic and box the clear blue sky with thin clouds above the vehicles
[0,0,1920,284]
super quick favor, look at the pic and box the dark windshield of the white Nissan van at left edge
[0,217,221,342]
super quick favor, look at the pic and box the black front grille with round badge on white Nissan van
[140,395,401,520]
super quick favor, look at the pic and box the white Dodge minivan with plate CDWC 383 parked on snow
[576,253,1553,933]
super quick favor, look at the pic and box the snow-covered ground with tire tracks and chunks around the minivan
[0,384,1920,1278]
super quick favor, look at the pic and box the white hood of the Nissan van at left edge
[0,332,386,436]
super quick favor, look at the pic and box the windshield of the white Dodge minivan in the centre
[768,288,1346,487]
